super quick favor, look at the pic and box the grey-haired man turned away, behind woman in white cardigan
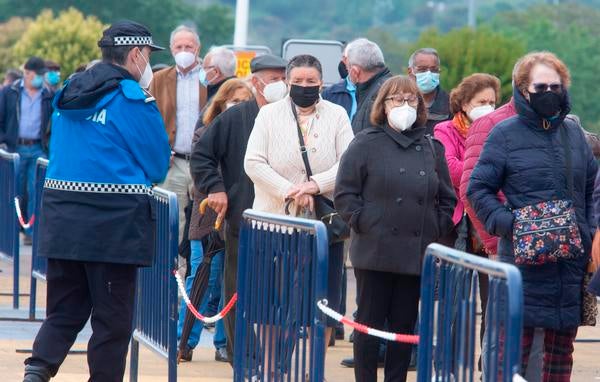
[346,38,392,135]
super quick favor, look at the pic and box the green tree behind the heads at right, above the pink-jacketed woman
[411,28,525,100]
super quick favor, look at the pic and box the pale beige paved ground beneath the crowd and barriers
[0,243,600,382]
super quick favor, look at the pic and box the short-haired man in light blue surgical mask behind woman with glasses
[408,48,452,135]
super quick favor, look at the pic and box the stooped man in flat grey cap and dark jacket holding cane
[190,55,287,363]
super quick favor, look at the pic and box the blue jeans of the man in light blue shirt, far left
[17,143,46,235]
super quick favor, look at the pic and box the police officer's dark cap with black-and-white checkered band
[98,20,165,50]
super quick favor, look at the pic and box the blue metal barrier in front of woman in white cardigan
[233,210,328,382]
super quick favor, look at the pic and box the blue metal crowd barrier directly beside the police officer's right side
[129,188,179,382]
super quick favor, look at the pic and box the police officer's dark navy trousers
[25,259,137,382]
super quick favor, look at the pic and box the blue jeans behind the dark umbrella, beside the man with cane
[177,240,227,349]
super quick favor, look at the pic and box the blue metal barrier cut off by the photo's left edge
[0,149,19,309]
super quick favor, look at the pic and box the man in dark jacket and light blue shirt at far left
[0,57,54,244]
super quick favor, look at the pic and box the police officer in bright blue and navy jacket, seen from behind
[24,21,171,382]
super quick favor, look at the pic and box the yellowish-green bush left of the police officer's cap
[13,8,105,81]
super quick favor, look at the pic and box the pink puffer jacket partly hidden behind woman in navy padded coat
[460,99,517,257]
